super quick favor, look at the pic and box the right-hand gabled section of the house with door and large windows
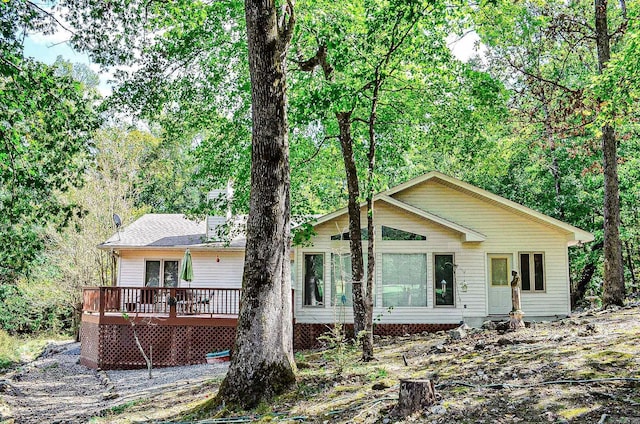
[295,171,593,333]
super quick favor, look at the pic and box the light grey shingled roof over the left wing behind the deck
[98,213,245,249]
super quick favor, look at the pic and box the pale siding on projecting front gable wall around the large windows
[295,201,485,323]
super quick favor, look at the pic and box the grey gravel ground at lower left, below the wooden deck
[0,343,228,424]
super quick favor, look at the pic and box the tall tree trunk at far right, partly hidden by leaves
[595,0,625,306]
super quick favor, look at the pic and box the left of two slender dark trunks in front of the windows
[336,112,364,344]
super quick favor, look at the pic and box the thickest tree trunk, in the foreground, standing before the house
[217,0,295,408]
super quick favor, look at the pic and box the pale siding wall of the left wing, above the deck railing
[118,249,244,288]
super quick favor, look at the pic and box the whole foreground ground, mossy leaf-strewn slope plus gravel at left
[0,303,640,424]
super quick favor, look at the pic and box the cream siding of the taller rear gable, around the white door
[394,180,570,316]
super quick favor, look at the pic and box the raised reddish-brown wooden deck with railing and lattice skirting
[80,287,240,369]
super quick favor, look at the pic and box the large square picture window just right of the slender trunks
[382,253,427,307]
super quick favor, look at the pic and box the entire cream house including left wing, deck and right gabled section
[81,172,593,368]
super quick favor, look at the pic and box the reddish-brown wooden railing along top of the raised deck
[82,287,240,317]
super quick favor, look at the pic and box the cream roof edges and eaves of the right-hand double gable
[314,171,594,244]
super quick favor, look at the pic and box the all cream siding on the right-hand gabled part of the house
[295,180,570,323]
